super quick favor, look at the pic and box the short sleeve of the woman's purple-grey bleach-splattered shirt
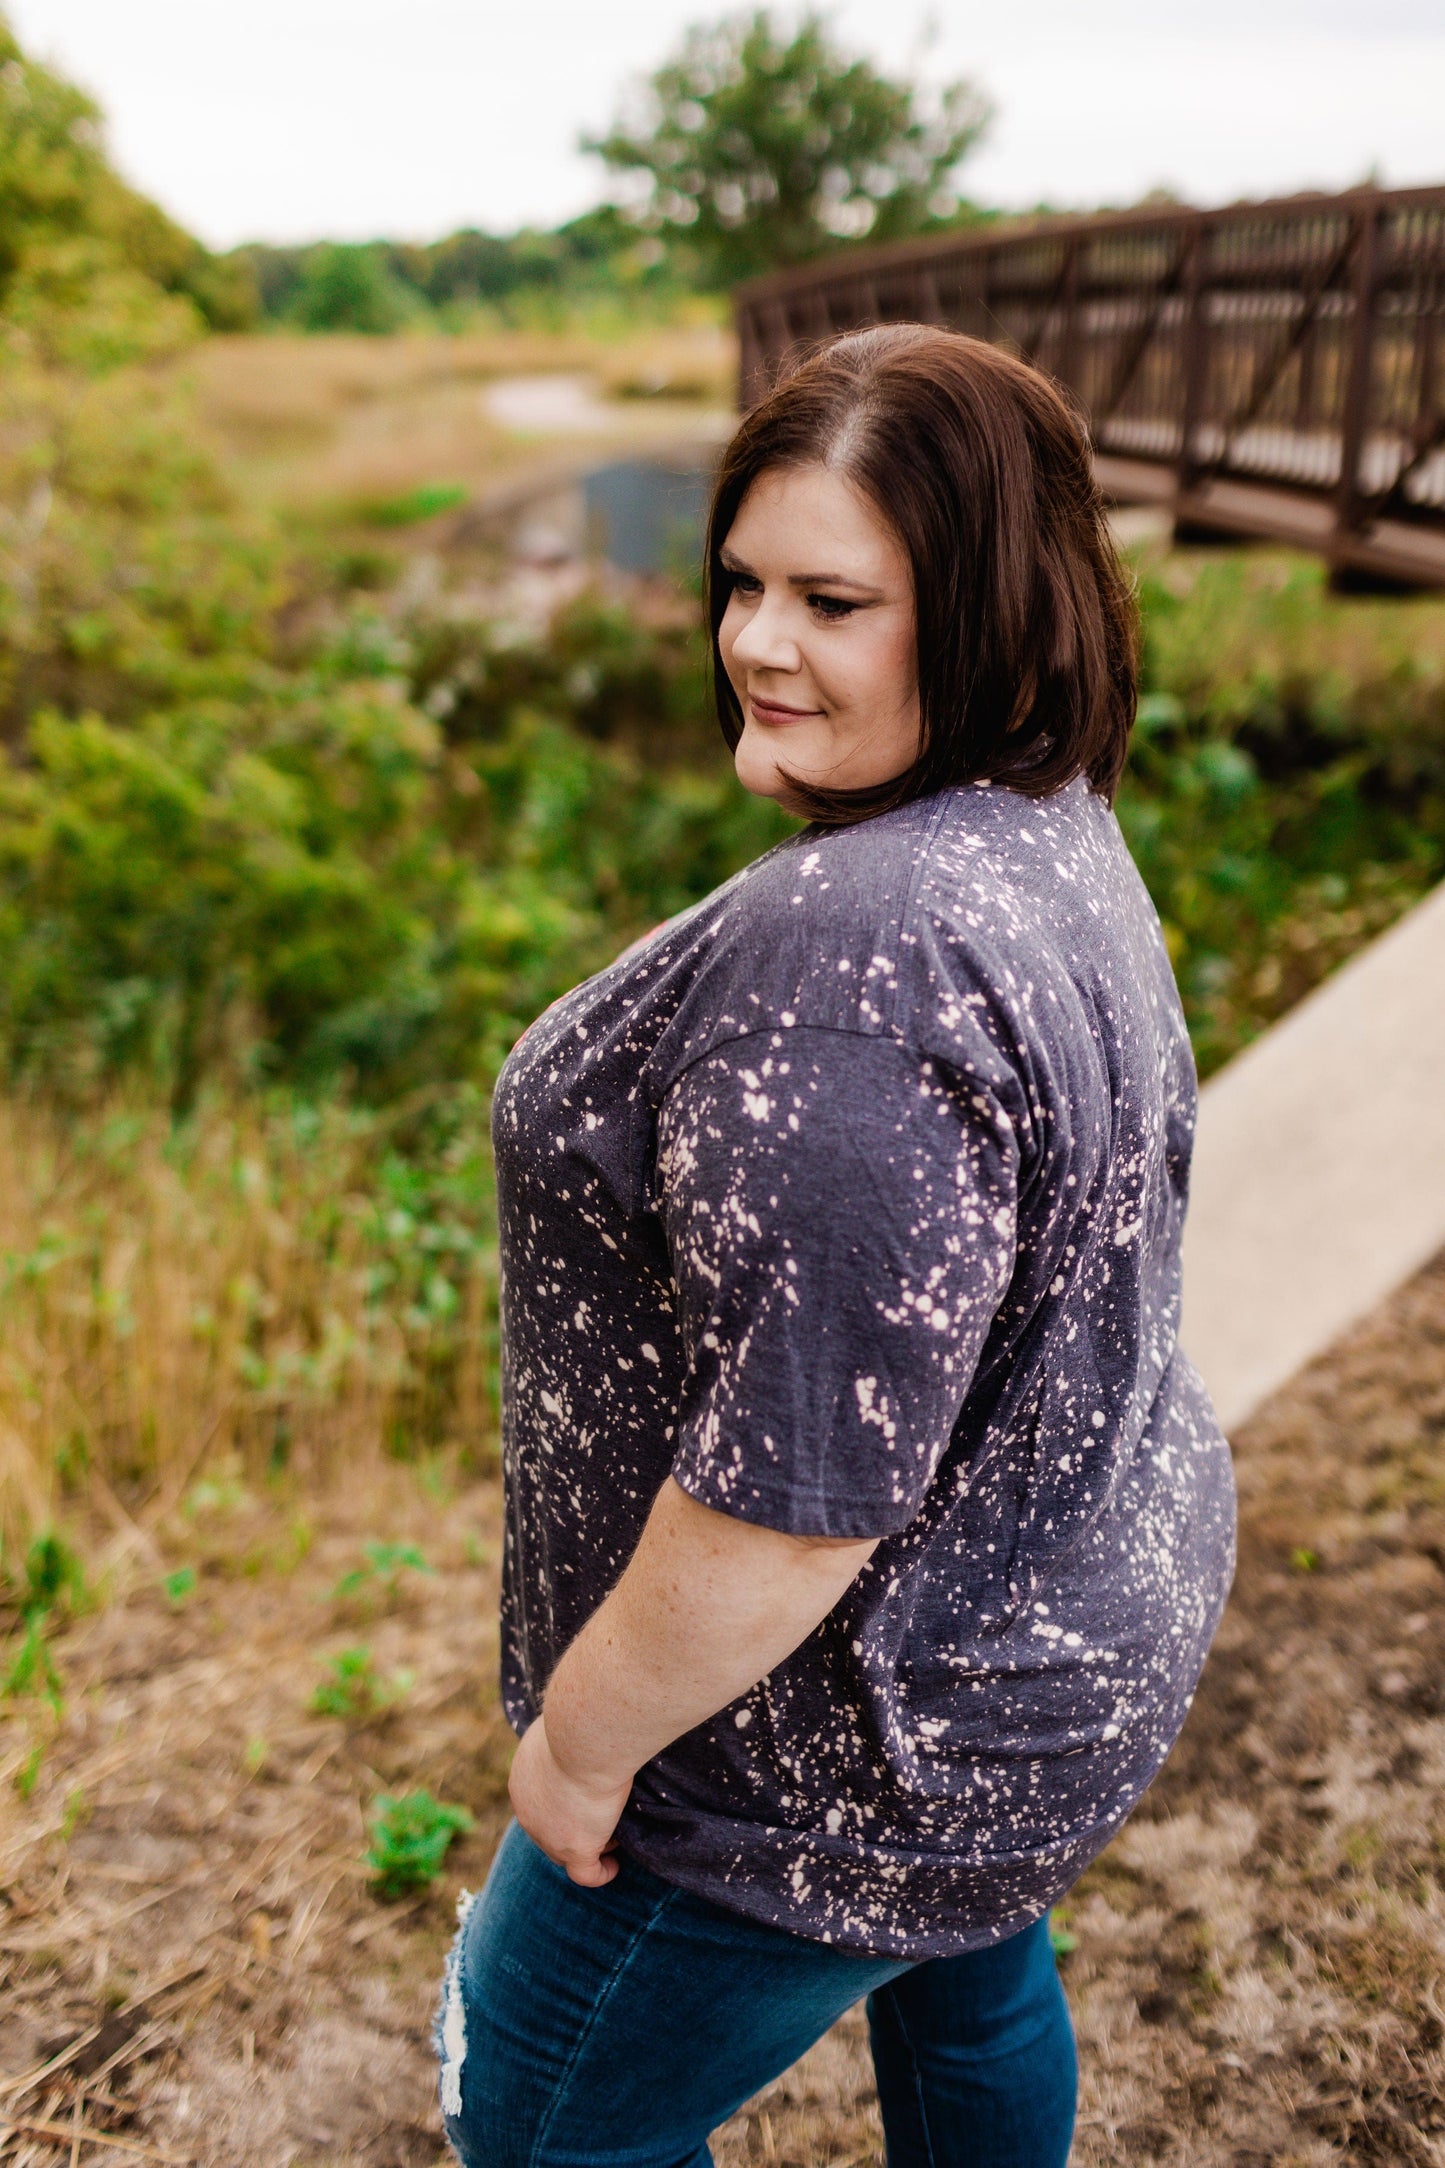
[656,1028,1018,1537]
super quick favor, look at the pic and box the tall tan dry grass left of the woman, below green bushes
[0,1101,490,1554]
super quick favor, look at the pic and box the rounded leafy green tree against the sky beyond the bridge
[583,11,990,284]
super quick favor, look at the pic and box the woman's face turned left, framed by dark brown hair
[717,466,919,804]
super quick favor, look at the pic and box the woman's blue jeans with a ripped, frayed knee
[438,1823,1077,2168]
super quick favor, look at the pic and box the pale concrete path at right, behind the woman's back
[1181,885,1445,1431]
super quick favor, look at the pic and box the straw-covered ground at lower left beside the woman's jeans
[0,1461,509,2168]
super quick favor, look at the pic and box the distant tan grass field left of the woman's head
[186,323,737,512]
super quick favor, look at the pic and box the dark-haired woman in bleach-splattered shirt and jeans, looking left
[440,325,1233,2168]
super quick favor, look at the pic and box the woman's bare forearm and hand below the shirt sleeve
[511,1476,877,1886]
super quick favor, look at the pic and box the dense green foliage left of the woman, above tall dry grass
[0,559,784,1108]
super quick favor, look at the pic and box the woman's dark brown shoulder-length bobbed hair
[704,323,1137,824]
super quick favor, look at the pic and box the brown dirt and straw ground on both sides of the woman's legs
[0,1257,1445,2168]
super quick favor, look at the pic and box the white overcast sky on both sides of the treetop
[11,0,1445,245]
